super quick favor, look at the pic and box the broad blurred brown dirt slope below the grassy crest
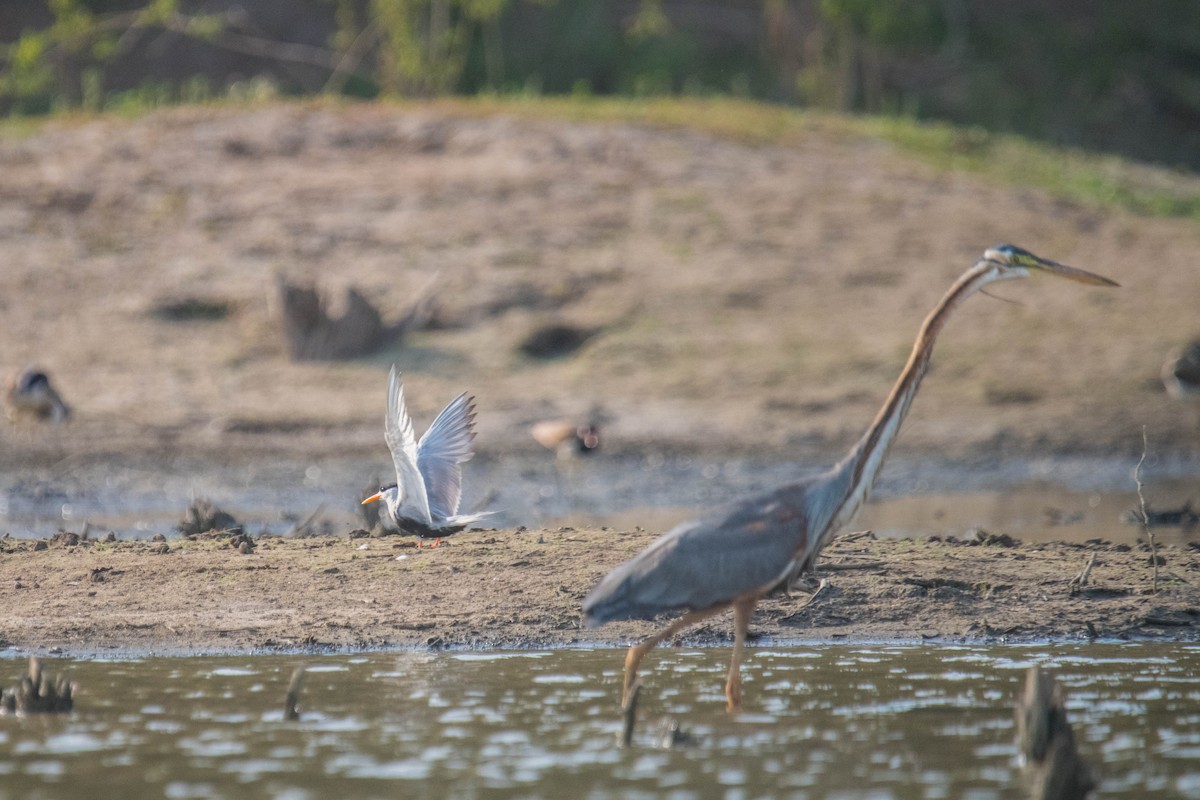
[0,104,1200,463]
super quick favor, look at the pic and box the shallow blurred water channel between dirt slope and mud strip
[0,453,1200,543]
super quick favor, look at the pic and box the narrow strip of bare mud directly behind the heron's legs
[0,529,1200,655]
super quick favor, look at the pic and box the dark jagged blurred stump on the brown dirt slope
[278,276,434,361]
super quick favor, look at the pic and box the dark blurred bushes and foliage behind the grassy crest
[0,0,1200,172]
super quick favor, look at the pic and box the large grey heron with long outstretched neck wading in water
[583,245,1117,711]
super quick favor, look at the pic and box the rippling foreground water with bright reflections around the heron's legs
[0,644,1200,800]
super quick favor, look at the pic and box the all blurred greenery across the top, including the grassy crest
[0,0,1200,218]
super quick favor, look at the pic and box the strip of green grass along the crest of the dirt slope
[0,95,1200,219]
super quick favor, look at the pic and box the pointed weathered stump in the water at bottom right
[1016,667,1096,800]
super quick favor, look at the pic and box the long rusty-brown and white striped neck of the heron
[822,264,995,539]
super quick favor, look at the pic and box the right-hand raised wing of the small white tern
[416,392,475,519]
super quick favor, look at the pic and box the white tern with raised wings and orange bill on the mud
[362,367,492,547]
